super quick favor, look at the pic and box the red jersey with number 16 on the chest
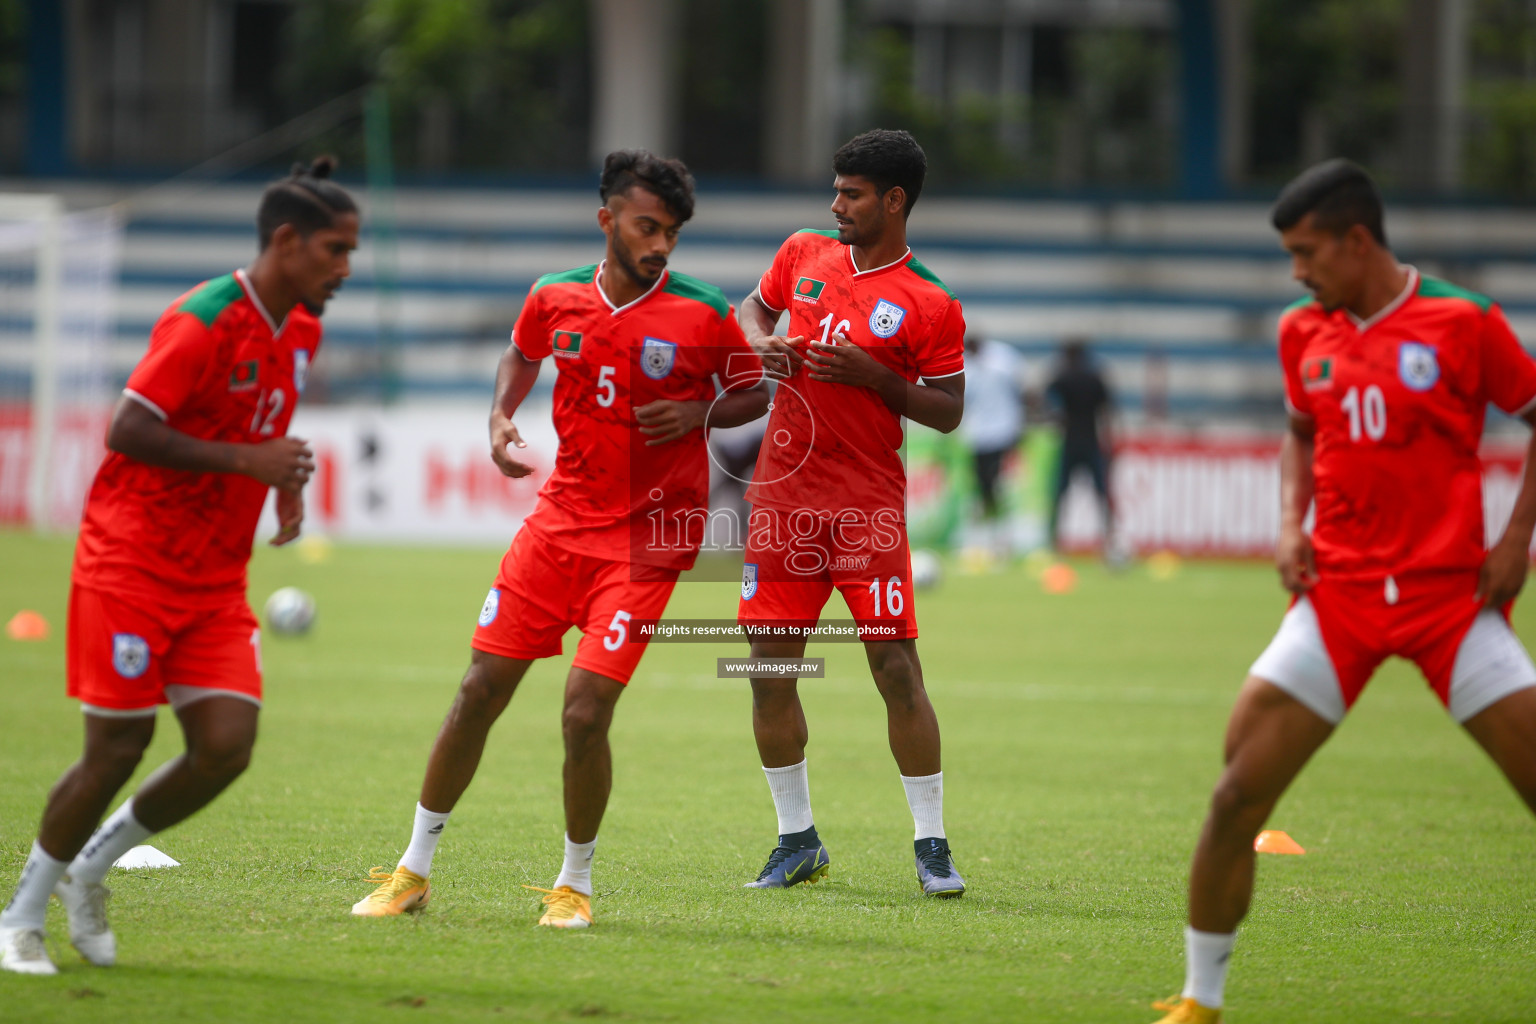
[746,230,965,520]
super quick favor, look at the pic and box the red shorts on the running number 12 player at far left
[66,583,261,715]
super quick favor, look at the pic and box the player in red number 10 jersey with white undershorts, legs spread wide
[1158,160,1536,1024]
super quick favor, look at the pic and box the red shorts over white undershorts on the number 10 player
[1307,571,1481,708]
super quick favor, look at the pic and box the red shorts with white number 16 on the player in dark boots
[736,507,917,642]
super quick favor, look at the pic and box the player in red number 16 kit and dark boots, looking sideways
[737,129,965,897]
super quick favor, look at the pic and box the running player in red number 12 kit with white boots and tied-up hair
[0,158,358,975]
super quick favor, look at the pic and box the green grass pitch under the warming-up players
[0,533,1536,1024]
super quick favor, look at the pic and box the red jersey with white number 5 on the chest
[511,264,762,568]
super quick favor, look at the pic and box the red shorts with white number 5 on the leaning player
[470,527,677,685]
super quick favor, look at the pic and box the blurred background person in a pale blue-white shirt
[960,333,1025,559]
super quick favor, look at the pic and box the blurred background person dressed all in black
[1046,338,1115,553]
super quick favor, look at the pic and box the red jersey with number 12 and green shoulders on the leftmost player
[74,270,319,603]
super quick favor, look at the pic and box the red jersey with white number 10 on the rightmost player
[1279,267,1536,577]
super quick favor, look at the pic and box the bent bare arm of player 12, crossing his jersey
[106,395,315,491]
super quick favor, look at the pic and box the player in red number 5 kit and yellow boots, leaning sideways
[352,150,768,927]
